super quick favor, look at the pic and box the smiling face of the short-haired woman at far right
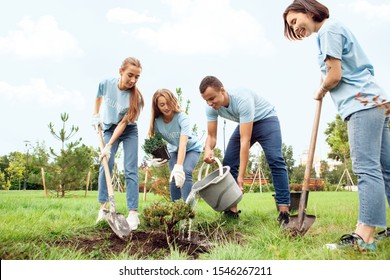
[286,11,318,39]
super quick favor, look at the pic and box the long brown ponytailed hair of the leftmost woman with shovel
[121,57,144,122]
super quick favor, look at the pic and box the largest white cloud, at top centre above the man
[133,0,273,56]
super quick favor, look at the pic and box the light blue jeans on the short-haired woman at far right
[348,108,390,227]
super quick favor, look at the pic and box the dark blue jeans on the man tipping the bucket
[223,117,290,206]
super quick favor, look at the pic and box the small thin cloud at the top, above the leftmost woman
[106,8,157,24]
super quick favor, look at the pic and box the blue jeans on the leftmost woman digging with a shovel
[98,125,139,210]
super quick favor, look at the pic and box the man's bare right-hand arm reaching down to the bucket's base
[237,122,253,191]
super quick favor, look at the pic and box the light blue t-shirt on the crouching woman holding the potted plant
[154,112,203,153]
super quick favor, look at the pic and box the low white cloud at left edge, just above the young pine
[0,79,85,110]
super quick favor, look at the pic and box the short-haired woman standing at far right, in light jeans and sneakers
[283,0,390,251]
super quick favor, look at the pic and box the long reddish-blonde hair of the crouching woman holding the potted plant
[148,88,181,137]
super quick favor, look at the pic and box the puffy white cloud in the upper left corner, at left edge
[0,16,83,60]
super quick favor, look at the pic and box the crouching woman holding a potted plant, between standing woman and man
[149,89,203,201]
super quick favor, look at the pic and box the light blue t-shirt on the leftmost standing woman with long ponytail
[96,78,135,130]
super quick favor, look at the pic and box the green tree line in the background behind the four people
[0,88,378,197]
